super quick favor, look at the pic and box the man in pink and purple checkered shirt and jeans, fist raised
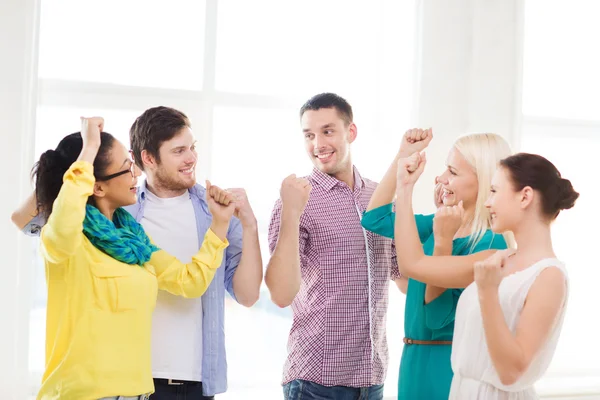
[265,93,399,400]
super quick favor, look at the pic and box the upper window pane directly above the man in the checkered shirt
[216,0,414,101]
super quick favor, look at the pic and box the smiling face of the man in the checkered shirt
[301,108,357,177]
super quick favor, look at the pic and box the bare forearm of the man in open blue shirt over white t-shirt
[233,220,263,307]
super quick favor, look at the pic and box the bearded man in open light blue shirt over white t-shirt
[128,107,262,400]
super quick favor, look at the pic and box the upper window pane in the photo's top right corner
[523,0,600,120]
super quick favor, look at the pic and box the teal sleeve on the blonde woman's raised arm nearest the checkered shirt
[361,203,433,243]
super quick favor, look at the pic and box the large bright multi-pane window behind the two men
[30,0,415,400]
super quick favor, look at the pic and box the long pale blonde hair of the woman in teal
[454,133,515,249]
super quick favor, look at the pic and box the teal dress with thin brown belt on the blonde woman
[362,204,506,400]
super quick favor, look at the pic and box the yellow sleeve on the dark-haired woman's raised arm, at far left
[40,161,95,264]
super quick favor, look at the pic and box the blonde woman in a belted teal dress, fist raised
[362,130,510,400]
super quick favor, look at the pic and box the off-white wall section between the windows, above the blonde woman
[414,0,523,212]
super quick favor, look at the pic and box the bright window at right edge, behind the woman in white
[521,0,600,394]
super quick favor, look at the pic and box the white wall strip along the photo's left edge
[0,0,38,400]
